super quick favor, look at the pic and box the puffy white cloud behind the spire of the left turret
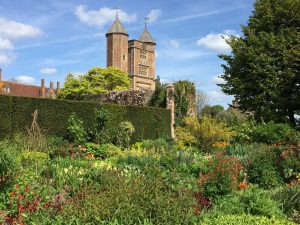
[75,5,136,28]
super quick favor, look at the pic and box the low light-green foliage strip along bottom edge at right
[200,214,295,225]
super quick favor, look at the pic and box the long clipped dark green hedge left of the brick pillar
[0,95,171,141]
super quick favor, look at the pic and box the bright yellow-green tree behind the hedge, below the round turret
[57,67,130,100]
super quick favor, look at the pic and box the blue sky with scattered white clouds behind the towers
[0,0,254,107]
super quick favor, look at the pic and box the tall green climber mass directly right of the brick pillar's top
[174,80,196,125]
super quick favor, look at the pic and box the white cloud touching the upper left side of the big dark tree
[197,30,238,52]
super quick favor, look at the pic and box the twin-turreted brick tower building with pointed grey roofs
[106,16,156,90]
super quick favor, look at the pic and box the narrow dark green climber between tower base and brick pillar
[149,76,167,108]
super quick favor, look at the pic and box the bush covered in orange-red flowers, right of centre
[198,152,242,197]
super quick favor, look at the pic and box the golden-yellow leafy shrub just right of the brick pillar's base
[176,116,234,152]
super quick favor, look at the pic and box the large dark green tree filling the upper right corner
[219,0,300,125]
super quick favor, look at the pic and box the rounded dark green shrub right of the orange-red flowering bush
[244,145,282,189]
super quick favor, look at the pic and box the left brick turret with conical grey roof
[106,15,128,73]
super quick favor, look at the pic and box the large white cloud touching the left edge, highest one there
[0,17,42,39]
